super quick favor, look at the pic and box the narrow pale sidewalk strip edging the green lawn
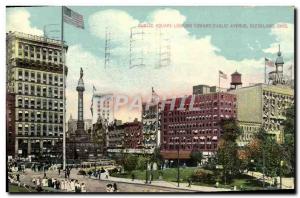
[91,177,230,192]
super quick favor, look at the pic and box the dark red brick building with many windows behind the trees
[160,92,236,160]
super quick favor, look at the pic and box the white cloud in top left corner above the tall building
[6,8,43,36]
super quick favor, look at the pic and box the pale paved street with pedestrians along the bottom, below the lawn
[20,169,229,192]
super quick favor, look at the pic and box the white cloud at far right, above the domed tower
[263,23,294,56]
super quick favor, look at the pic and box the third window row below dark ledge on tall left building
[16,97,64,111]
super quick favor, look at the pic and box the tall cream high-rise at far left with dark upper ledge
[6,32,67,158]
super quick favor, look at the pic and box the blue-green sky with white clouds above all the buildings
[6,6,294,121]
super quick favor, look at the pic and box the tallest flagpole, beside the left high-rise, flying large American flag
[61,6,66,170]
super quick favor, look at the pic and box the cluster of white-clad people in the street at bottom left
[32,177,87,192]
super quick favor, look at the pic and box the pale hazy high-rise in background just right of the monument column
[92,93,115,124]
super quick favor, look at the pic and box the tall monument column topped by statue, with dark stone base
[66,68,97,163]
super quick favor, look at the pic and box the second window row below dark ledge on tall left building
[17,83,64,98]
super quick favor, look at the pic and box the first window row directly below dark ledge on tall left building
[17,69,63,86]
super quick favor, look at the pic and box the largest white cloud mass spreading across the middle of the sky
[68,9,293,120]
